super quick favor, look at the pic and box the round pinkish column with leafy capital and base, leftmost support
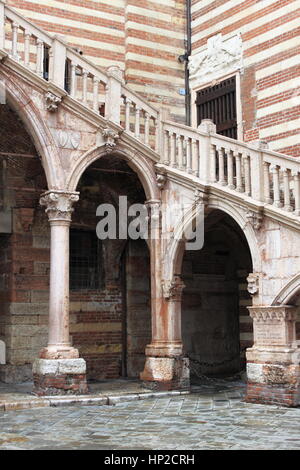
[33,191,87,395]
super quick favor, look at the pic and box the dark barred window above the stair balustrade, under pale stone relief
[196,77,237,139]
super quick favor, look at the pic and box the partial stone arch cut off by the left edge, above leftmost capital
[0,71,64,189]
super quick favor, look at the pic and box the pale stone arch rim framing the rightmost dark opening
[164,199,261,280]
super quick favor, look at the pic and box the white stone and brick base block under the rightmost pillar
[245,363,300,407]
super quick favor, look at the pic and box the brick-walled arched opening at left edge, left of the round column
[0,104,50,383]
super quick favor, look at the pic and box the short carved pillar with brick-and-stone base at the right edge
[246,305,300,406]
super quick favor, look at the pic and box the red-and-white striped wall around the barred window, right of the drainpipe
[192,0,300,156]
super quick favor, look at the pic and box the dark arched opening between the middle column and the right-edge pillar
[182,210,253,382]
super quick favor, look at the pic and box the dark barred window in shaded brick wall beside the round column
[70,229,102,290]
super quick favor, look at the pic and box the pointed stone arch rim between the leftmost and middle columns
[67,142,160,200]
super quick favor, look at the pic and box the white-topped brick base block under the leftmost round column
[33,358,88,396]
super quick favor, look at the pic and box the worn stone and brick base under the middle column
[140,356,190,390]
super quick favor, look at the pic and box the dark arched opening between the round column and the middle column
[70,153,151,382]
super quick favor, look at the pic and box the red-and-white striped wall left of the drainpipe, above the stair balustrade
[7,0,186,121]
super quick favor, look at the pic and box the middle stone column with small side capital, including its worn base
[140,207,189,390]
